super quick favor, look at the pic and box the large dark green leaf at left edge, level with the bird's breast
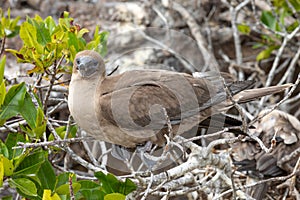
[0,83,26,125]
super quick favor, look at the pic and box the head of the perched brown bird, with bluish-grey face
[73,50,105,78]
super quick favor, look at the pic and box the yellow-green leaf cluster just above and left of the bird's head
[7,12,108,74]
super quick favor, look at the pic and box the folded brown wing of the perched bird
[98,70,226,130]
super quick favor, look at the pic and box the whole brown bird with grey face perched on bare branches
[68,50,291,148]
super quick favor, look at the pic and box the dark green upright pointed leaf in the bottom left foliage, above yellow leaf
[37,160,56,191]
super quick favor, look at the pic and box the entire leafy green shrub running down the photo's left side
[0,9,136,200]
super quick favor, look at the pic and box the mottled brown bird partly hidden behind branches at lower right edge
[231,109,300,199]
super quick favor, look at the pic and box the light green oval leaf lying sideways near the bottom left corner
[9,178,37,196]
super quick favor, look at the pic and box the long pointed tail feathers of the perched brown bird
[233,84,293,103]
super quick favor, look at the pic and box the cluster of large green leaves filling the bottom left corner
[0,133,136,200]
